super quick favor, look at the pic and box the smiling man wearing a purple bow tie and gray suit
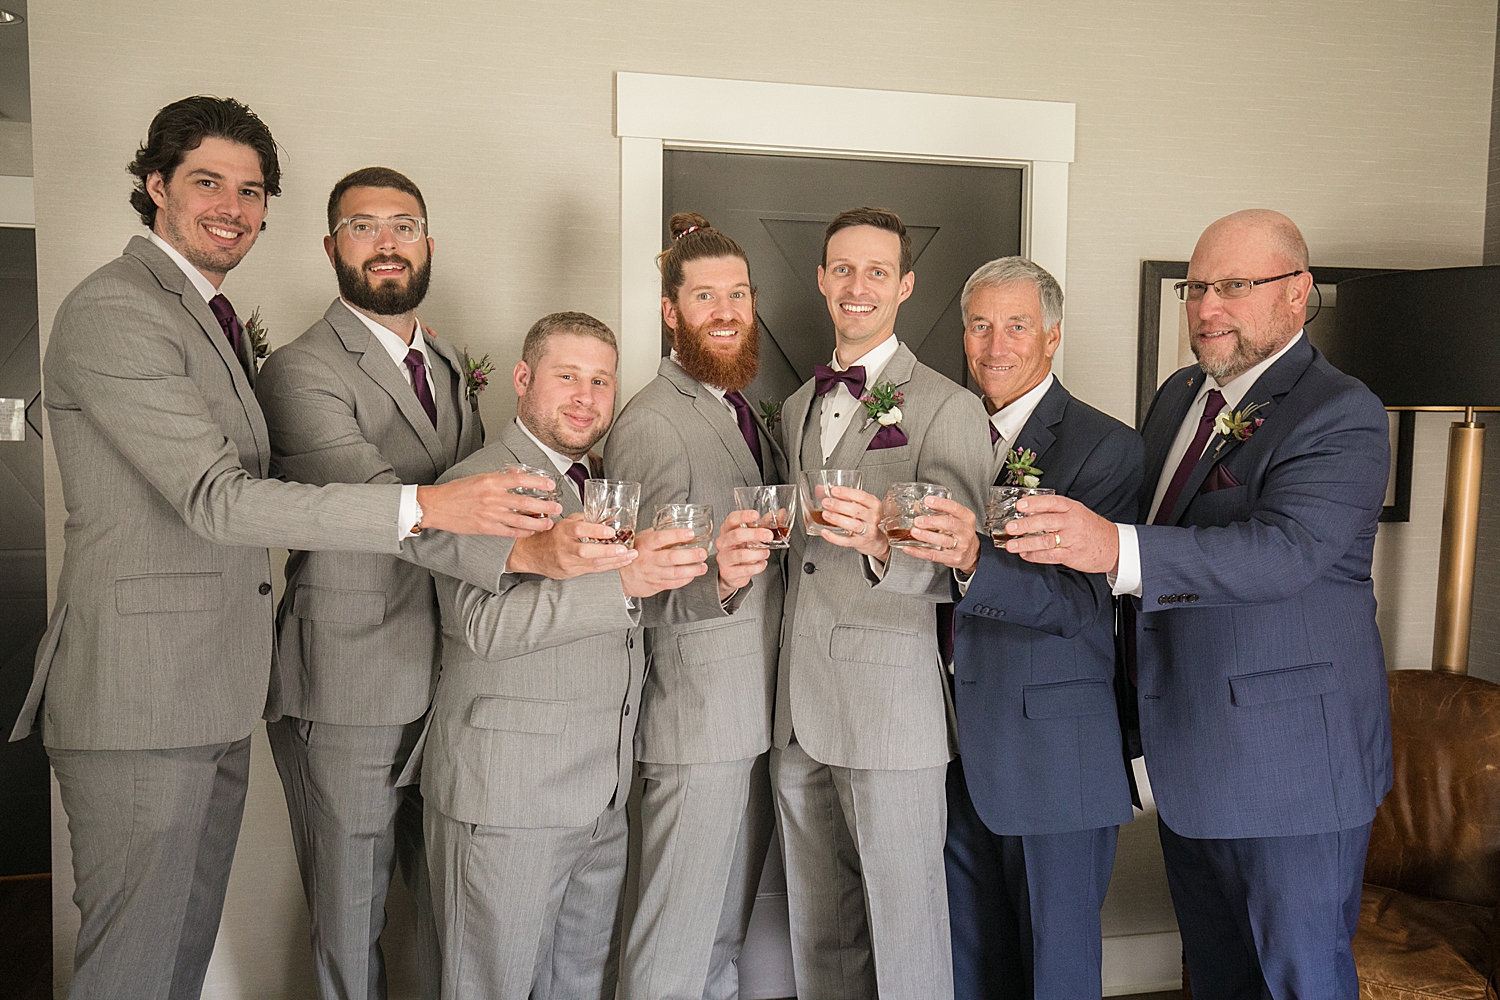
[771,208,993,1000]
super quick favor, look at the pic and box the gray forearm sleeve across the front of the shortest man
[438,571,641,660]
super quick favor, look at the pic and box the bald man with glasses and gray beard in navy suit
[1007,210,1392,1000]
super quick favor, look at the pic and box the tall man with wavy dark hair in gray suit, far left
[12,97,555,1000]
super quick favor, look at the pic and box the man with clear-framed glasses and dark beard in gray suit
[255,166,485,1000]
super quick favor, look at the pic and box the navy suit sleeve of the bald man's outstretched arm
[1136,390,1391,613]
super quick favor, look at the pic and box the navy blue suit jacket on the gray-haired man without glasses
[954,382,1143,835]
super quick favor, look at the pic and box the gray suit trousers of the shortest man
[423,805,627,1000]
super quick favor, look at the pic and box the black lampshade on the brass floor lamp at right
[1313,265,1500,406]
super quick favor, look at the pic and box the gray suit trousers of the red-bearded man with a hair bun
[620,754,773,1000]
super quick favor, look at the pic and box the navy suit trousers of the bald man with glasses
[1158,819,1370,1000]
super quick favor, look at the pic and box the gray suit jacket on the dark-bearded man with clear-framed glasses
[255,298,485,726]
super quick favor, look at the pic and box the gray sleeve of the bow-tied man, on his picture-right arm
[867,390,995,603]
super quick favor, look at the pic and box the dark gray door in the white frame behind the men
[662,150,1022,410]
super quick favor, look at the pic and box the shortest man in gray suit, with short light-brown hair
[420,312,708,1000]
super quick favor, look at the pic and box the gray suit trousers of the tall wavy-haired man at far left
[47,736,251,1000]
